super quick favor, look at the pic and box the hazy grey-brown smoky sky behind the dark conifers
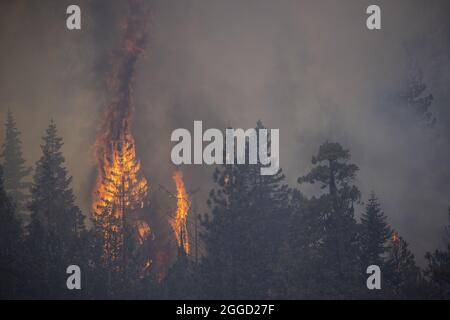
[0,0,450,261]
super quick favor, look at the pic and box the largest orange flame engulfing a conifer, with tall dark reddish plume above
[92,0,150,260]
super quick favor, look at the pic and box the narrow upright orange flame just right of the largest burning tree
[169,170,189,254]
